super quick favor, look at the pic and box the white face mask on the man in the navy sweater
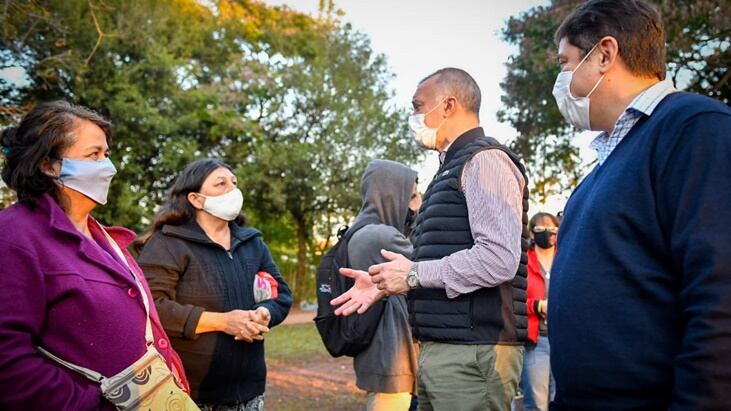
[553,43,604,130]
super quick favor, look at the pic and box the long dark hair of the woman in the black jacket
[135,158,246,251]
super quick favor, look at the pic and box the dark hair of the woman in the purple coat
[0,100,112,206]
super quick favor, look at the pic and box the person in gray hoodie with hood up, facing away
[348,160,421,411]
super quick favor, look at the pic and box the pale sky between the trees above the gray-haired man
[264,0,596,214]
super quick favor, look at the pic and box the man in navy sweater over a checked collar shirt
[548,0,731,410]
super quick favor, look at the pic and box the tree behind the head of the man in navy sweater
[498,0,731,201]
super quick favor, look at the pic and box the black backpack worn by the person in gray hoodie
[315,221,386,357]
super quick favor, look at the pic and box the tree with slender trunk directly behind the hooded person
[222,19,419,300]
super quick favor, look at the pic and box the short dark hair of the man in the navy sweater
[554,0,666,80]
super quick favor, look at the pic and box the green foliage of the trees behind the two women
[0,0,418,300]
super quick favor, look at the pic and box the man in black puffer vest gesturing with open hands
[333,68,528,411]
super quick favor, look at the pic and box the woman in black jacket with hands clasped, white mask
[138,159,292,411]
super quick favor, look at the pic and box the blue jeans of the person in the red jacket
[520,336,556,411]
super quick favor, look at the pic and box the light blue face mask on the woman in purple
[58,158,117,205]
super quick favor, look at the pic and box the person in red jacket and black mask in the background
[520,213,559,411]
